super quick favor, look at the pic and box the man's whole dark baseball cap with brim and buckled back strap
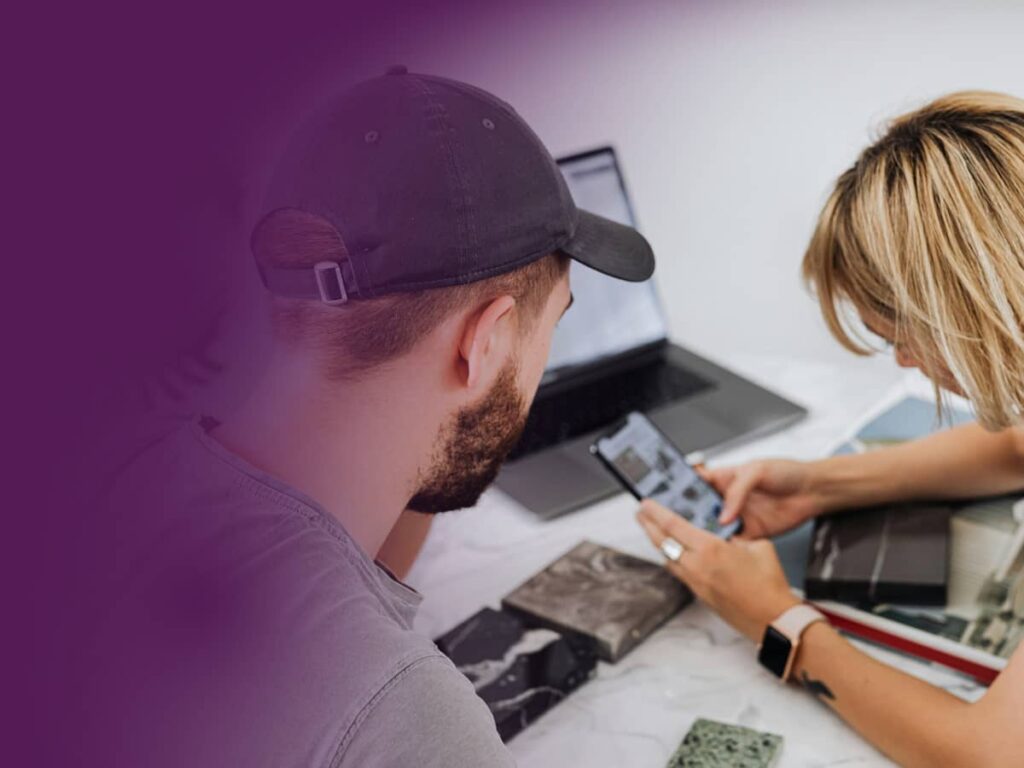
[260,67,654,304]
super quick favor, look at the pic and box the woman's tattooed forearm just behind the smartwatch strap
[794,624,1024,768]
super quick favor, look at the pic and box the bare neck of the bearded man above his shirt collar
[212,354,440,558]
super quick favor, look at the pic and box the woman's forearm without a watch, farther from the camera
[811,424,1024,512]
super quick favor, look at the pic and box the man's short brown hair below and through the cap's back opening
[252,209,569,379]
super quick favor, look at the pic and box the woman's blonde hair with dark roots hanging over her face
[803,91,1024,429]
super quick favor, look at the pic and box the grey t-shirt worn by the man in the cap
[103,422,512,768]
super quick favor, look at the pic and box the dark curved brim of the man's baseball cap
[561,211,654,283]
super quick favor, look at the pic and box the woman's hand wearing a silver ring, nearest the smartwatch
[637,499,800,642]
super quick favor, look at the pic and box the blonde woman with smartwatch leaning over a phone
[639,92,1024,768]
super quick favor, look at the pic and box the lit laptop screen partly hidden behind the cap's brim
[544,147,668,381]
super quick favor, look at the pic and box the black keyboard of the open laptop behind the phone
[509,360,712,459]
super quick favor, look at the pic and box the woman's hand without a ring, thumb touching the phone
[701,459,824,539]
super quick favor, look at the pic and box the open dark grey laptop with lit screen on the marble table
[497,146,807,518]
